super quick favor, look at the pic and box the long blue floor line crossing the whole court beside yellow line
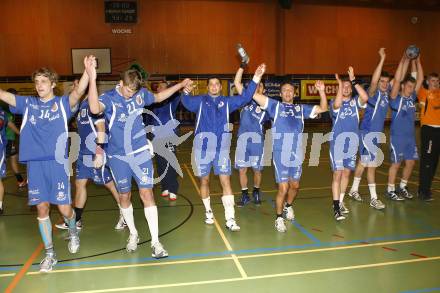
[0,230,440,271]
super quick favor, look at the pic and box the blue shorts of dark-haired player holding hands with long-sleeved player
[273,150,302,183]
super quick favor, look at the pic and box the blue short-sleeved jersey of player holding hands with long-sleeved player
[265,98,316,151]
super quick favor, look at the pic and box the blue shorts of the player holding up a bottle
[235,143,264,171]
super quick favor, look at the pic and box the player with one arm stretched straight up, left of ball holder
[348,48,390,210]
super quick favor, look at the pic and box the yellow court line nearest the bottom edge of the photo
[64,256,440,293]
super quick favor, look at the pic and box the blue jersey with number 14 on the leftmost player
[9,96,74,162]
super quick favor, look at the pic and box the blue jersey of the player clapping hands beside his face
[330,96,367,140]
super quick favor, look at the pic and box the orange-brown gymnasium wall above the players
[0,0,440,77]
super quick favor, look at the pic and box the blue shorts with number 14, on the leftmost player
[27,160,72,205]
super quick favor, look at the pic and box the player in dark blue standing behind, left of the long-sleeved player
[149,81,180,201]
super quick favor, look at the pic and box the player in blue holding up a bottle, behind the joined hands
[234,66,269,207]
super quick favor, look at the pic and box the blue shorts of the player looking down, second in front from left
[108,151,154,193]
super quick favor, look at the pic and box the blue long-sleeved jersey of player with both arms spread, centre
[182,81,257,151]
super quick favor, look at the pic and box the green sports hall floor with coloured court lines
[0,127,440,292]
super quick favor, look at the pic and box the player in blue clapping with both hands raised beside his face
[330,67,368,221]
